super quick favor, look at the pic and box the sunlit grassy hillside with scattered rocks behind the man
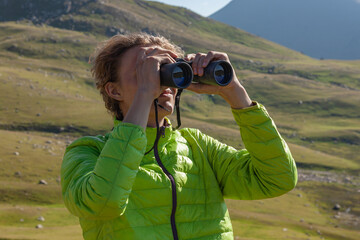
[0,0,360,239]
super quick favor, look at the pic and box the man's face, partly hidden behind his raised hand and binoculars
[116,45,177,118]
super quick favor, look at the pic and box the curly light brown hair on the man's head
[90,32,184,120]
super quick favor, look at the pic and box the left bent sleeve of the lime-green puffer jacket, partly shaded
[61,123,147,219]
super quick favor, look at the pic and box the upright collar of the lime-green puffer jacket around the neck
[114,117,174,151]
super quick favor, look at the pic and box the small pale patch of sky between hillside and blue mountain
[146,0,232,17]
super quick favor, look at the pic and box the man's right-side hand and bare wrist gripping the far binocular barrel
[184,51,252,109]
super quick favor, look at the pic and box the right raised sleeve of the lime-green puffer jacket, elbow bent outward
[190,102,297,200]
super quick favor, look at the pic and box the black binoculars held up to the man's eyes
[160,58,233,89]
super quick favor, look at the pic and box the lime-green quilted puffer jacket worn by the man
[61,102,297,240]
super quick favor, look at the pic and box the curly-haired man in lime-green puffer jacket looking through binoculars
[61,33,297,239]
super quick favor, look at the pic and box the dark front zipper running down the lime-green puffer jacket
[154,126,178,240]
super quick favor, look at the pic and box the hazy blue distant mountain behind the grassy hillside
[210,0,360,59]
